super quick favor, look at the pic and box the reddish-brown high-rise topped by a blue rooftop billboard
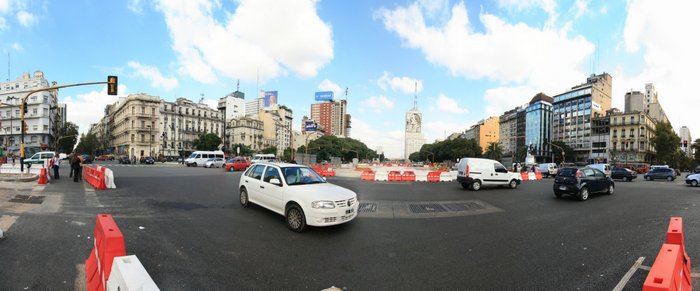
[311,100,350,137]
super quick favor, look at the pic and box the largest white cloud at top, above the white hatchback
[156,0,333,83]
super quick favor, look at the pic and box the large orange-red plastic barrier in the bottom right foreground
[642,217,692,291]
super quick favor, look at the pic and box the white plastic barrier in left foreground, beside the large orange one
[107,255,160,291]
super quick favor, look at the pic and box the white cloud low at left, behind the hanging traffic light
[60,84,128,133]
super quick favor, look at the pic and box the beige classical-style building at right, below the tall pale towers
[610,111,656,164]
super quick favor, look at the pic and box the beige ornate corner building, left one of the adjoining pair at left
[105,93,161,159]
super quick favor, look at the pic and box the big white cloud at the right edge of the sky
[613,0,700,135]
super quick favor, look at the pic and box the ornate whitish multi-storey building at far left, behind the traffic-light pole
[0,71,60,156]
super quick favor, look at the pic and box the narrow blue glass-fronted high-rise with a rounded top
[525,93,554,162]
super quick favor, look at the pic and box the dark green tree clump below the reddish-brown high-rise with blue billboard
[308,135,377,162]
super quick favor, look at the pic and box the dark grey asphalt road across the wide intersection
[0,164,700,290]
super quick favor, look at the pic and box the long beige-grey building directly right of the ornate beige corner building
[155,98,224,157]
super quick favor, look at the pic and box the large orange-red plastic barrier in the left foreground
[85,214,126,291]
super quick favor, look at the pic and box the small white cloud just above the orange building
[484,86,537,116]
